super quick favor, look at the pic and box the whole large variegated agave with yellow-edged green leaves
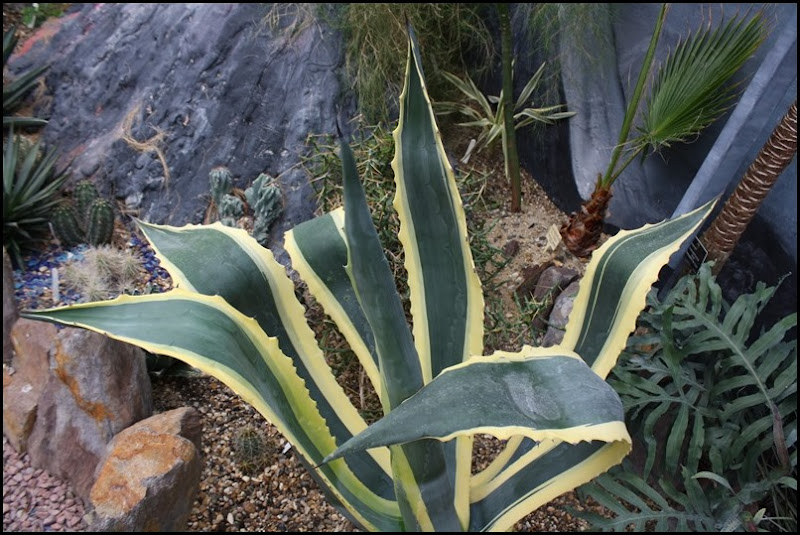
[26,31,708,531]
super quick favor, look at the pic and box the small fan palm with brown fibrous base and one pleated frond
[561,4,766,256]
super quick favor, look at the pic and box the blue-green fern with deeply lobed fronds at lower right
[587,264,797,532]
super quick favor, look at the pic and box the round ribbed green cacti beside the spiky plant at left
[52,180,114,247]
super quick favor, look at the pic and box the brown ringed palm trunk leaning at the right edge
[700,100,797,274]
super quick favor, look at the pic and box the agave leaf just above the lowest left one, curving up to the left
[139,222,394,499]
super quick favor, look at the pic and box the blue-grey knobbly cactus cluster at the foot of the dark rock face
[208,167,283,245]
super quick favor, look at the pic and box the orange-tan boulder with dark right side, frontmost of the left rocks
[90,409,202,532]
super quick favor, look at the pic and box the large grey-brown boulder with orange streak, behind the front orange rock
[28,329,152,497]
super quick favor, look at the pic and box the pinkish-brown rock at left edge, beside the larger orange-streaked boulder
[3,318,57,453]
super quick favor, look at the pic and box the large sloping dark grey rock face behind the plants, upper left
[10,4,343,262]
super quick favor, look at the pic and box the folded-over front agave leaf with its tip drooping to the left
[324,347,629,462]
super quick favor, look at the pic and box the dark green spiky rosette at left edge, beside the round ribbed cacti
[3,127,67,267]
